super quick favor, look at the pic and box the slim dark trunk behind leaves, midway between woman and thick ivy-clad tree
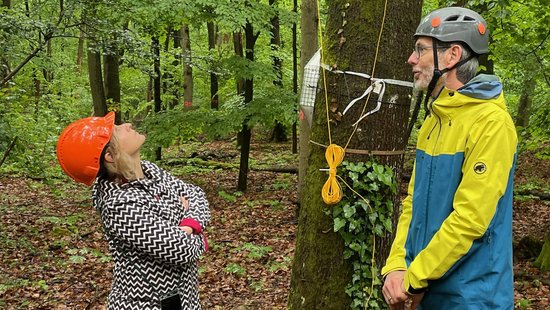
[237,22,259,192]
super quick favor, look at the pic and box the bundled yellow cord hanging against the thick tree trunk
[321,144,346,205]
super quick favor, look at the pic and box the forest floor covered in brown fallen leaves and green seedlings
[0,141,550,310]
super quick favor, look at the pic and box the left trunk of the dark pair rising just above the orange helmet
[87,41,108,116]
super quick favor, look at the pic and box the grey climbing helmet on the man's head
[414,7,489,55]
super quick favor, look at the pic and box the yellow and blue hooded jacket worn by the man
[382,75,517,309]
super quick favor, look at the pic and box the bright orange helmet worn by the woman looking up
[57,112,115,186]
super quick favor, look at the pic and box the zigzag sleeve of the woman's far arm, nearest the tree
[166,172,210,230]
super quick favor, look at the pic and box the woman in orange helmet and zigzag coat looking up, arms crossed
[57,112,210,309]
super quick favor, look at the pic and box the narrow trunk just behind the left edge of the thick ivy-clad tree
[298,0,319,204]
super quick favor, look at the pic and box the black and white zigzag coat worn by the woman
[93,161,210,310]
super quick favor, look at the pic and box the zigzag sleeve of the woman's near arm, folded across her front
[101,195,204,265]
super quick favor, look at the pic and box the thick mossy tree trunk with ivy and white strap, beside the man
[288,0,421,309]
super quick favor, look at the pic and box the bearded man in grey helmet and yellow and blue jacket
[382,7,517,310]
